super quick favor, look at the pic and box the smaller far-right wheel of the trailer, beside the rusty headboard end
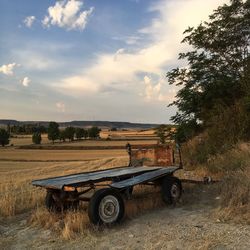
[161,176,182,205]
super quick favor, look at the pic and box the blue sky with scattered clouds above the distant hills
[0,0,228,123]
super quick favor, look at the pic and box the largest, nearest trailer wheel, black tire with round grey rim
[88,188,124,225]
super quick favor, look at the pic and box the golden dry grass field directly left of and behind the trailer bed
[0,157,127,217]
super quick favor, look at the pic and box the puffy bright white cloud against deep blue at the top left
[42,0,94,30]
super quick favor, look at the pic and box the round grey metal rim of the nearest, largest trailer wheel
[99,195,120,223]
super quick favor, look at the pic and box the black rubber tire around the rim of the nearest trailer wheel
[88,188,125,226]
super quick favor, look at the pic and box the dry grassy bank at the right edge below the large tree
[184,137,250,224]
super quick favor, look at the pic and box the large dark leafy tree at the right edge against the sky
[167,0,250,141]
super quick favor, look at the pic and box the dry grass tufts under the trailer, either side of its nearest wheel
[29,186,165,239]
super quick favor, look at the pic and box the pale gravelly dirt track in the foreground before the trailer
[0,183,250,250]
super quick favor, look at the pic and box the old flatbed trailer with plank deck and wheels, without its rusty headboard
[32,166,182,225]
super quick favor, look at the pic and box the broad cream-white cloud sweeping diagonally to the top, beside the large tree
[57,0,228,101]
